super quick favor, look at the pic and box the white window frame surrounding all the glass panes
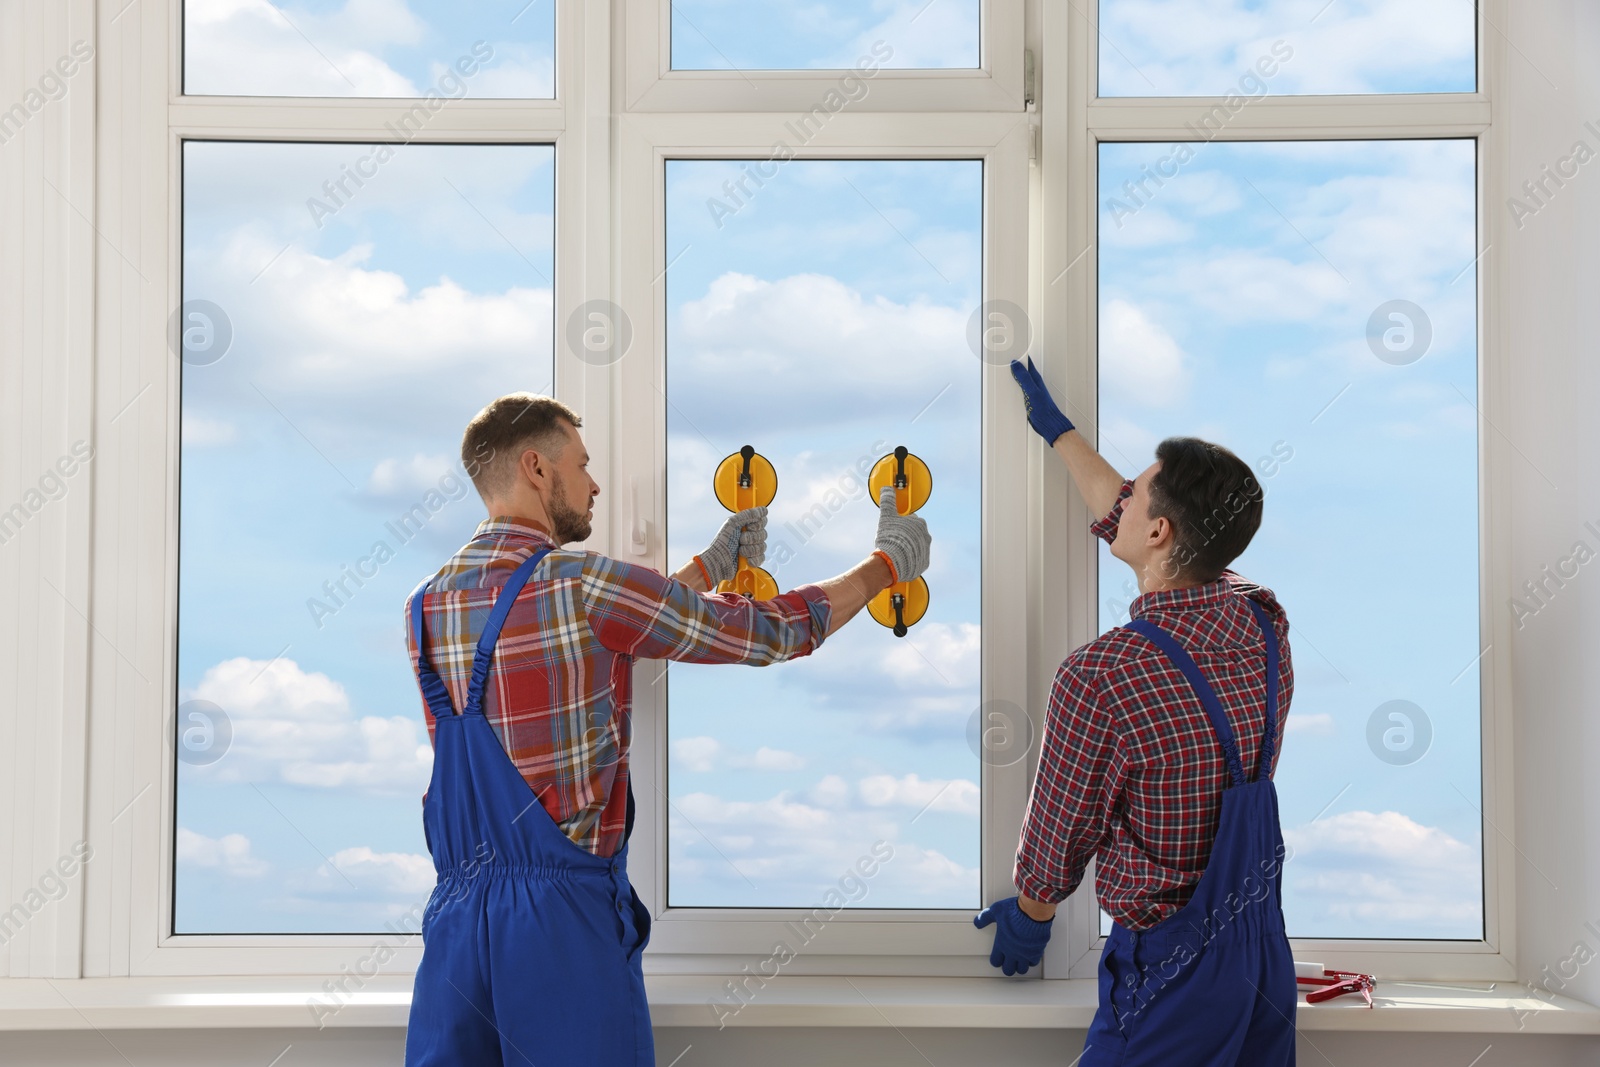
[8,0,1515,981]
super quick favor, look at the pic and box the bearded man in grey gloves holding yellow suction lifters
[396,394,930,1067]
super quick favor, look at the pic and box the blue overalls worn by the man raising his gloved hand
[1082,600,1298,1067]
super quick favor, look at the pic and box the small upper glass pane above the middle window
[672,0,979,69]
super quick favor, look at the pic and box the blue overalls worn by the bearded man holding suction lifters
[405,549,656,1067]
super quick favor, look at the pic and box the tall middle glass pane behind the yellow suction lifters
[667,160,982,907]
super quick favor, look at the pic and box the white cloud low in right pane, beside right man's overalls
[1283,809,1482,937]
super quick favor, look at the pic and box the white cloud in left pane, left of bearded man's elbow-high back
[186,656,434,793]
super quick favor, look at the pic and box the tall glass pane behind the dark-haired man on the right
[1099,141,1483,939]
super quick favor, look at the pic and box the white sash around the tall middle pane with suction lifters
[614,115,1038,974]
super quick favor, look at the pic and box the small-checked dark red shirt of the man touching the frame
[1014,480,1294,929]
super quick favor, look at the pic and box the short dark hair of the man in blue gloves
[1150,437,1264,582]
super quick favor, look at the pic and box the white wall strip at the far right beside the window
[1510,0,1600,1017]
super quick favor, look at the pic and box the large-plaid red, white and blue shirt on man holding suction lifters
[405,517,829,856]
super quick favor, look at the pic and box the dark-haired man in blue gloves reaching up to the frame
[974,360,1296,1067]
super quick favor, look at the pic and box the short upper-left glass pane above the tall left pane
[184,0,555,99]
